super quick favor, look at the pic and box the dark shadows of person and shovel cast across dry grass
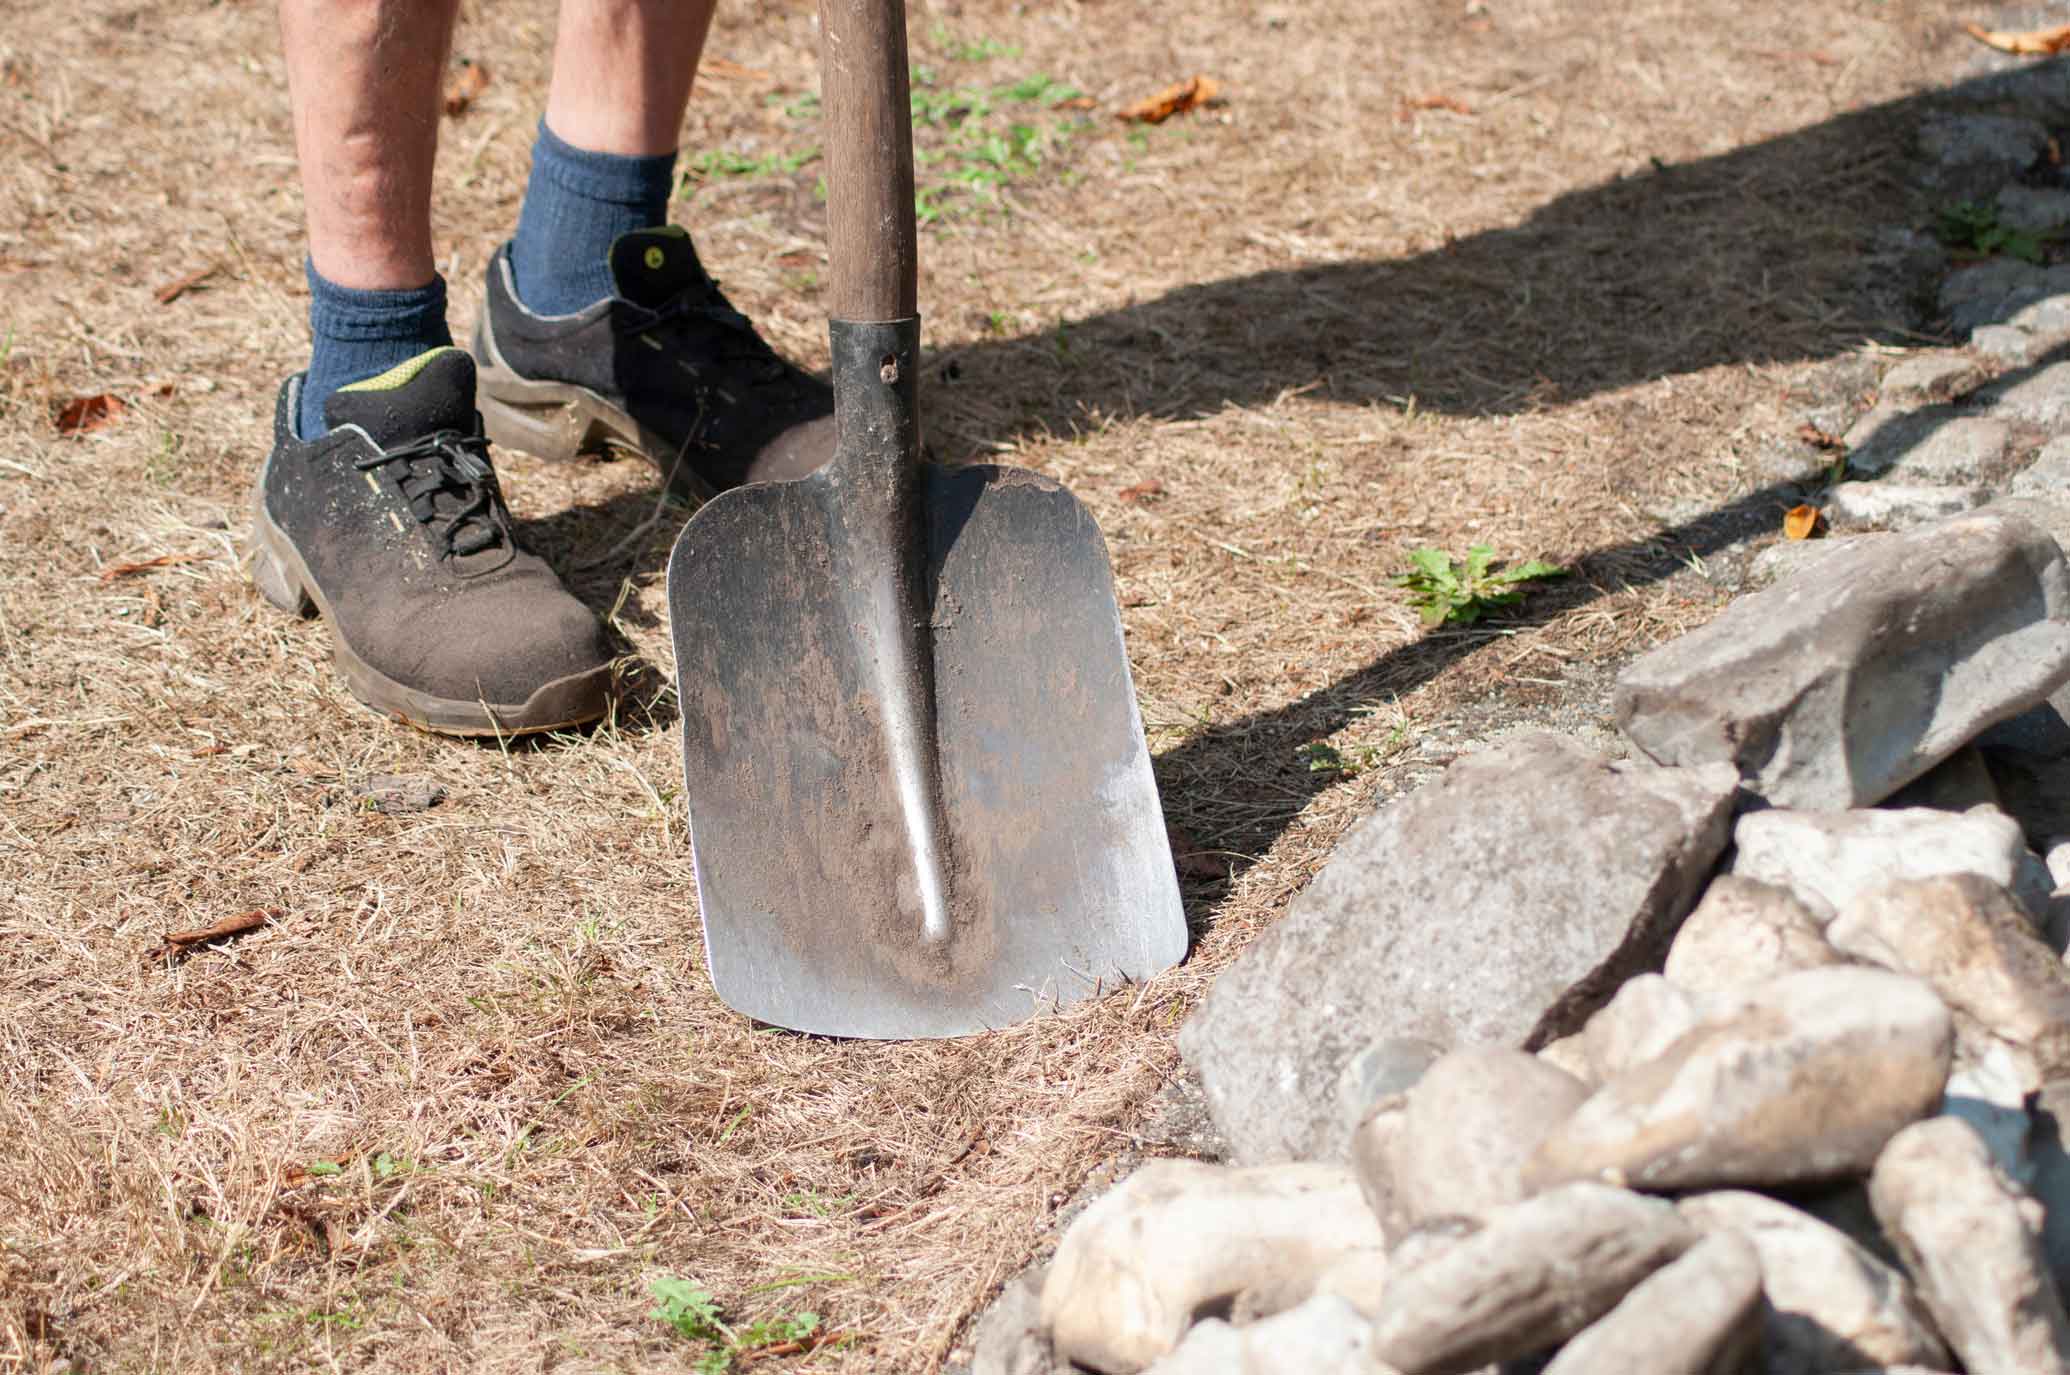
[521,62,2070,911]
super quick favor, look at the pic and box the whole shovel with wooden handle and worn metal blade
[669,0,1186,1037]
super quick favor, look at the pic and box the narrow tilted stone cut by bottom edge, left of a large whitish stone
[1544,1232,1762,1375]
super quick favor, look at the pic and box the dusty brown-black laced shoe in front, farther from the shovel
[250,348,611,735]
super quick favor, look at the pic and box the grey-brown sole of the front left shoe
[246,499,611,737]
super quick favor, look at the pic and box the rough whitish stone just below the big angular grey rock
[1733,808,2053,923]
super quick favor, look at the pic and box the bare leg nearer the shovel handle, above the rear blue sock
[546,0,716,155]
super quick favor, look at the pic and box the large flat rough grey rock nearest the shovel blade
[1180,735,1735,1164]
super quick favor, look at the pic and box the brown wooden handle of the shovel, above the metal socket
[820,0,919,321]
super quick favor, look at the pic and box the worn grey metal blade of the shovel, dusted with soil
[669,455,1186,1037]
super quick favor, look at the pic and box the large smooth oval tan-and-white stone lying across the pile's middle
[1524,965,1954,1191]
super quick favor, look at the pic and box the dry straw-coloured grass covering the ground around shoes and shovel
[0,0,2012,1371]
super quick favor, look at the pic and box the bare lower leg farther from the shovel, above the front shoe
[279,0,457,290]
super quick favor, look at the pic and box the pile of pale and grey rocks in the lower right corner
[979,511,2070,1375]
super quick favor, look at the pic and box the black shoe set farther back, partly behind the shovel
[474,226,834,501]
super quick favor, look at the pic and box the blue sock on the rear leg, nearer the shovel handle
[511,120,675,315]
